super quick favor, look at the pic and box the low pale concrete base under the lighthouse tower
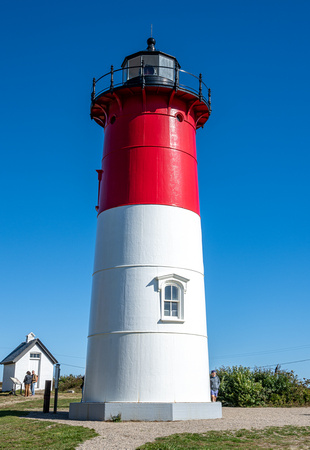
[69,402,222,422]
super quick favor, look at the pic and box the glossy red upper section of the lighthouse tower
[93,89,199,214]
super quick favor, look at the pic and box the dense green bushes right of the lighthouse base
[217,366,310,406]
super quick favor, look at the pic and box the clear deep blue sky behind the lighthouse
[0,0,310,379]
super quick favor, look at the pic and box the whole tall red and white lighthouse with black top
[70,38,221,421]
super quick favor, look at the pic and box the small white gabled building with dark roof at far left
[0,333,57,392]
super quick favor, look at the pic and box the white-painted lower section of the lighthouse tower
[84,205,210,402]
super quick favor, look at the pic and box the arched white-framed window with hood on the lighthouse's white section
[157,274,189,323]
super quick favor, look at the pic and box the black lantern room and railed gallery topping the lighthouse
[91,37,211,128]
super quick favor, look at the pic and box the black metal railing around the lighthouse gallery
[91,60,211,112]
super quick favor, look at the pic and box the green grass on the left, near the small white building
[0,393,98,450]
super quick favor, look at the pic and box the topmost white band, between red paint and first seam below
[94,205,203,273]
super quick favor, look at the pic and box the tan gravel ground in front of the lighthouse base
[26,408,310,450]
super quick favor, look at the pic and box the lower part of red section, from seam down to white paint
[99,147,199,214]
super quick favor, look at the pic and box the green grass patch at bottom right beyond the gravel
[139,426,310,450]
